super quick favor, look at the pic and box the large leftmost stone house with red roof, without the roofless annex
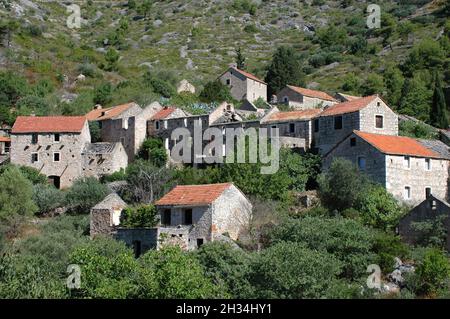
[10,116,91,188]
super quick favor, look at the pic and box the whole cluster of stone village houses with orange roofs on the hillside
[0,66,450,254]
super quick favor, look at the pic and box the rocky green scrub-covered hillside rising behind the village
[0,0,446,117]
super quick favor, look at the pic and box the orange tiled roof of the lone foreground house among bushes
[155,183,233,206]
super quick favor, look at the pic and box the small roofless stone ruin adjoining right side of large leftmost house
[81,142,128,177]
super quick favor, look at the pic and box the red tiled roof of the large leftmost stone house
[11,116,86,134]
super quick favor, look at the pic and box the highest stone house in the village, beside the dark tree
[219,66,267,103]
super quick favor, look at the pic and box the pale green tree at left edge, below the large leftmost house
[0,167,38,222]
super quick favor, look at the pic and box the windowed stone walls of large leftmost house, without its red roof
[11,121,91,188]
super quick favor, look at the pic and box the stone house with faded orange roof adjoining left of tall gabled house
[260,109,322,151]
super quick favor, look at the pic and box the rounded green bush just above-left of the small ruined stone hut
[65,177,109,214]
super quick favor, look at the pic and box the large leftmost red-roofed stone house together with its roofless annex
[10,116,127,188]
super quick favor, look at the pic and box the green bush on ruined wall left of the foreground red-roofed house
[120,205,159,228]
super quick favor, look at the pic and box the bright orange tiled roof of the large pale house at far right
[354,131,441,158]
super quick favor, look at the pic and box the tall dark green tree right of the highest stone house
[265,46,305,96]
